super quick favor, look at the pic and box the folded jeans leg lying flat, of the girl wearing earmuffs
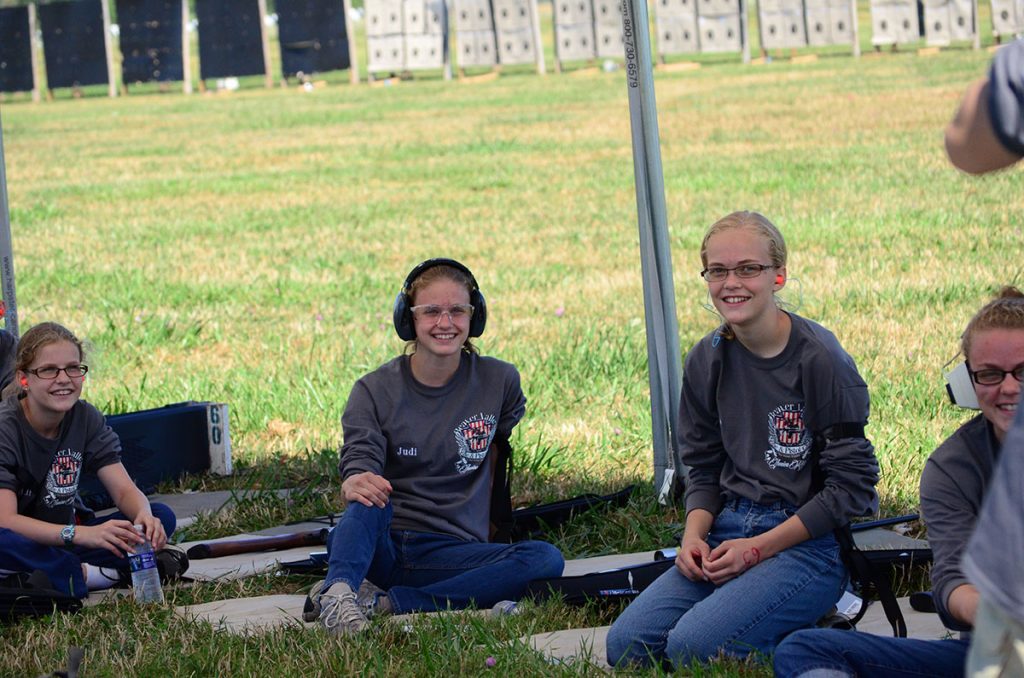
[388,532,564,612]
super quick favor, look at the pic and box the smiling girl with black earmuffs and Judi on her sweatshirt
[304,259,563,635]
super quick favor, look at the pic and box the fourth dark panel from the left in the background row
[196,0,264,80]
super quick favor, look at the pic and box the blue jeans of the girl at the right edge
[774,629,970,678]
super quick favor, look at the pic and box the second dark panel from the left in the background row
[39,0,110,89]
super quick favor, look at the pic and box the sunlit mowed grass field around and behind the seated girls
[0,49,1024,675]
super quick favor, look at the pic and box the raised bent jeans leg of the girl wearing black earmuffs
[324,502,395,591]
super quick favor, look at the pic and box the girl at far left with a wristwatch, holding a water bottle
[0,323,181,598]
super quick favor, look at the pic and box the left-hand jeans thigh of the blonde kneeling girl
[606,567,715,667]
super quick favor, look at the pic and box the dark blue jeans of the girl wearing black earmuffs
[324,502,565,613]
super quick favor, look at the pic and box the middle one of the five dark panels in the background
[117,0,184,85]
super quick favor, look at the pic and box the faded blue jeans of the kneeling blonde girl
[607,500,847,669]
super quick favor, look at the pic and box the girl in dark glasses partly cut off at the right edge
[775,287,1024,678]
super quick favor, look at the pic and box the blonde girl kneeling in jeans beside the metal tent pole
[607,212,879,669]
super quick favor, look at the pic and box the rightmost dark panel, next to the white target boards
[276,0,350,78]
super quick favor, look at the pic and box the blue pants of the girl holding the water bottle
[0,504,177,598]
